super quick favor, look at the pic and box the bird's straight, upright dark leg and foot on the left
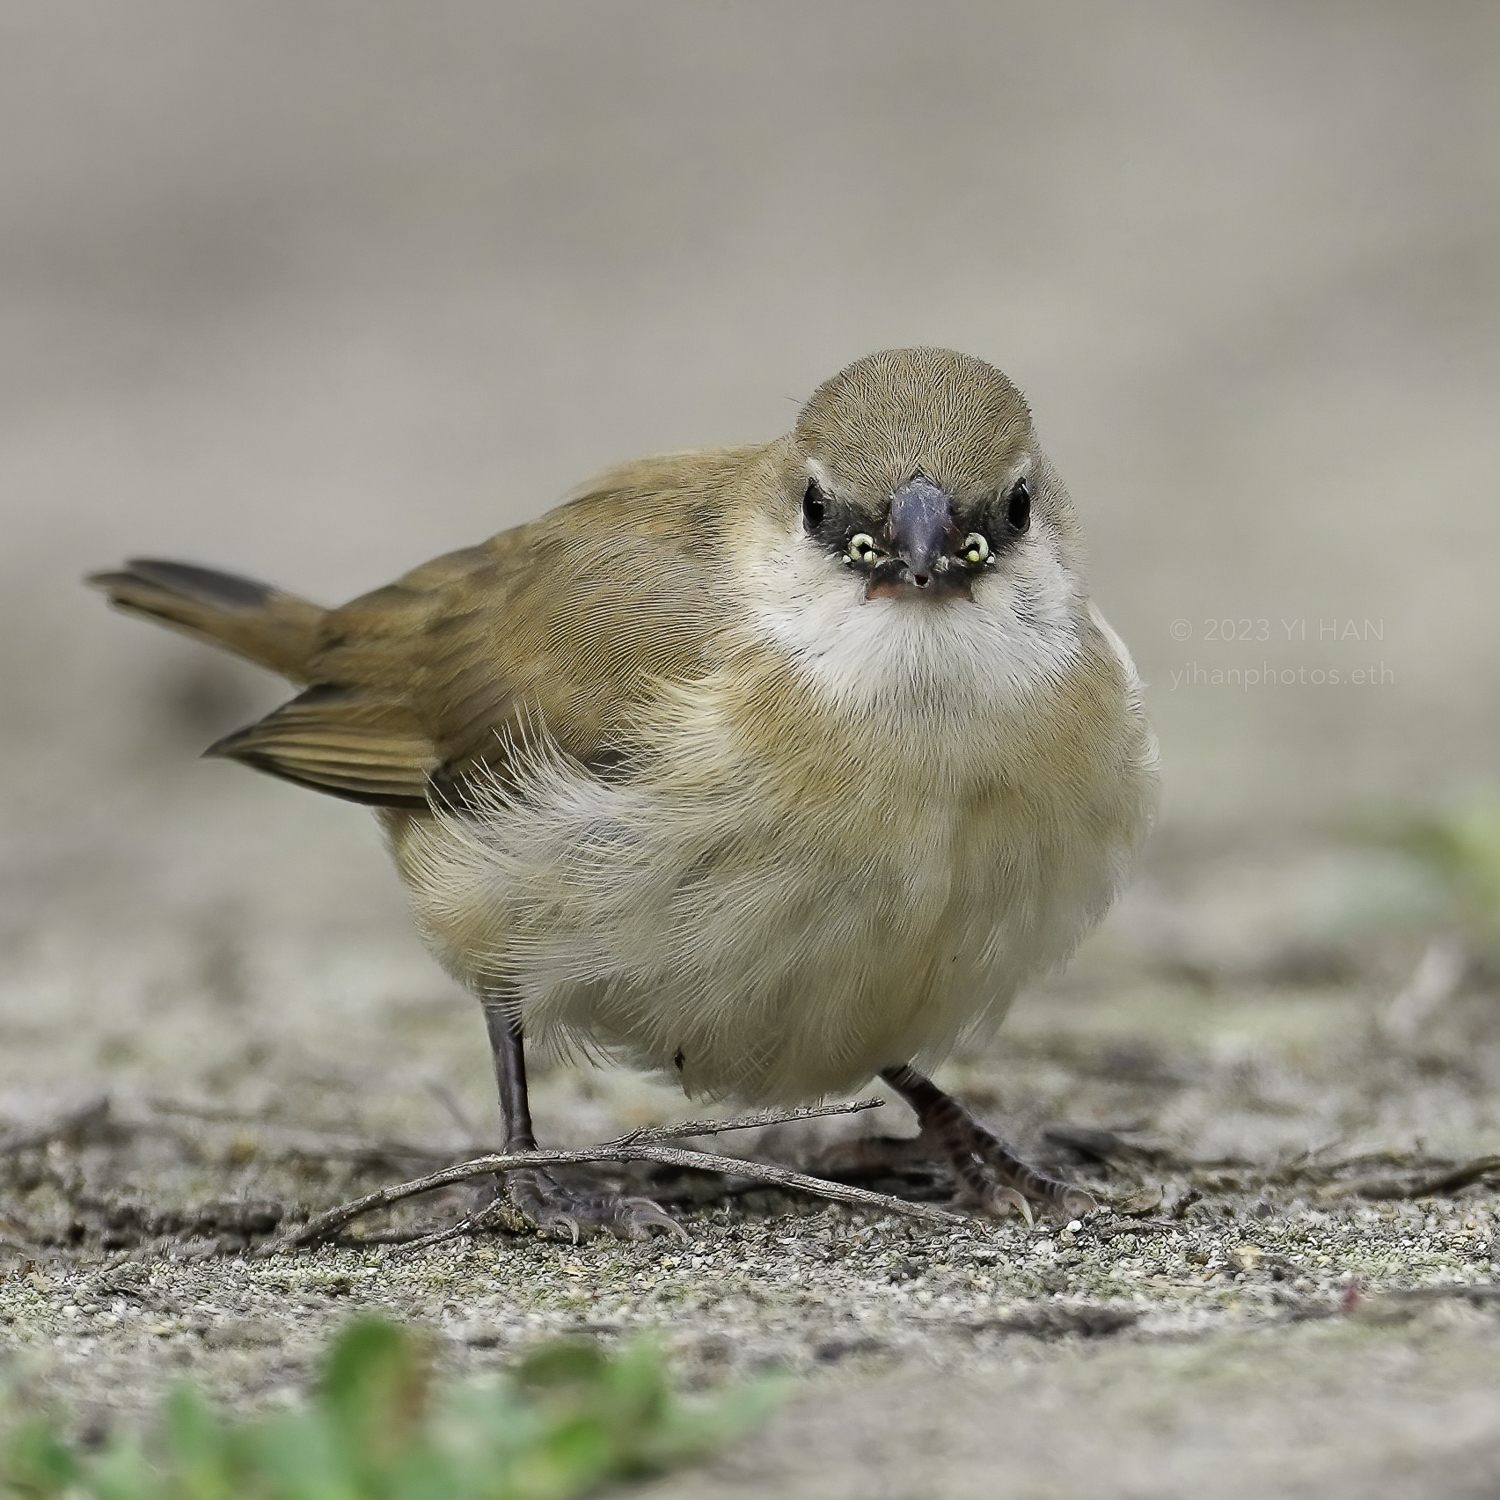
[483,996,689,1245]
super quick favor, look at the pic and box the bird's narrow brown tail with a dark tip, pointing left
[87,558,327,683]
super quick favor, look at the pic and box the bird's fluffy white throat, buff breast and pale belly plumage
[398,575,1151,1101]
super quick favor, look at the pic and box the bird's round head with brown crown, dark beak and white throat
[729,350,1091,722]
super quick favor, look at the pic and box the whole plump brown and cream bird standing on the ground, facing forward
[87,348,1158,1241]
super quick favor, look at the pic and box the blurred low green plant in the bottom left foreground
[0,1320,776,1500]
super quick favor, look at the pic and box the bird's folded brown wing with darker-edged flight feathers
[212,449,759,807]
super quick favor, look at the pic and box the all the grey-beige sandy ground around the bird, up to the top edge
[0,0,1500,1500]
